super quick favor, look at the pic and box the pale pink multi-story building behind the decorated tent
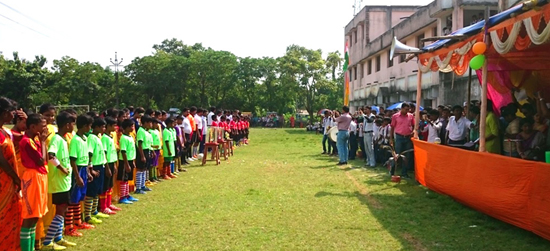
[345,0,502,111]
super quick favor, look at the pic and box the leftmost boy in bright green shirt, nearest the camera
[43,112,76,250]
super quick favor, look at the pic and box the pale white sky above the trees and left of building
[0,0,431,66]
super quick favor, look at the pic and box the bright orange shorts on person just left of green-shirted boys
[21,169,48,219]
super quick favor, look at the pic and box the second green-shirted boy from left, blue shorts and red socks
[65,115,95,236]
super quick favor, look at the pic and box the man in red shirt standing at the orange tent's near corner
[390,102,415,178]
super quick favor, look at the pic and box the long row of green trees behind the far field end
[0,38,343,118]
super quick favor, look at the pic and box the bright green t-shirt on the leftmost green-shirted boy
[48,133,73,193]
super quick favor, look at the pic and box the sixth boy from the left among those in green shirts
[135,115,155,194]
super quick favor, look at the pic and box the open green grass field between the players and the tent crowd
[71,129,550,250]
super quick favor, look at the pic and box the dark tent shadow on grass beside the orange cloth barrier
[315,167,550,250]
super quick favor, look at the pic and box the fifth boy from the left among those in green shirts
[117,119,138,204]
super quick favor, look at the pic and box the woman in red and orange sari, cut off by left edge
[0,97,22,250]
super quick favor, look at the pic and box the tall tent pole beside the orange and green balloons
[479,6,490,152]
